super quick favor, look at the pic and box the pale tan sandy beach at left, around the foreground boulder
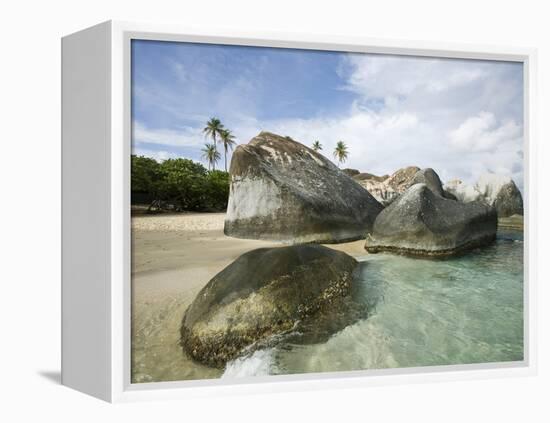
[132,213,366,382]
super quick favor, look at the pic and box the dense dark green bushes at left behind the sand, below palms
[132,156,229,211]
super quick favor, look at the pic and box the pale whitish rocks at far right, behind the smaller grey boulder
[445,174,523,217]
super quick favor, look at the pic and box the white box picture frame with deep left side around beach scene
[62,21,537,402]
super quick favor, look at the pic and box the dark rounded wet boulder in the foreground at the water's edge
[181,244,358,367]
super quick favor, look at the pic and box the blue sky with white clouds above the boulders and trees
[132,40,523,189]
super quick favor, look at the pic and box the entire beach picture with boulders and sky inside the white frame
[126,38,528,384]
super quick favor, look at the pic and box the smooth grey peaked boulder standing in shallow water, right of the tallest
[365,184,497,256]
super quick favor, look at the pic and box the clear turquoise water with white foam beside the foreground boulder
[224,231,523,377]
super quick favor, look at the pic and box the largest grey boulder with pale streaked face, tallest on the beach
[224,132,383,243]
